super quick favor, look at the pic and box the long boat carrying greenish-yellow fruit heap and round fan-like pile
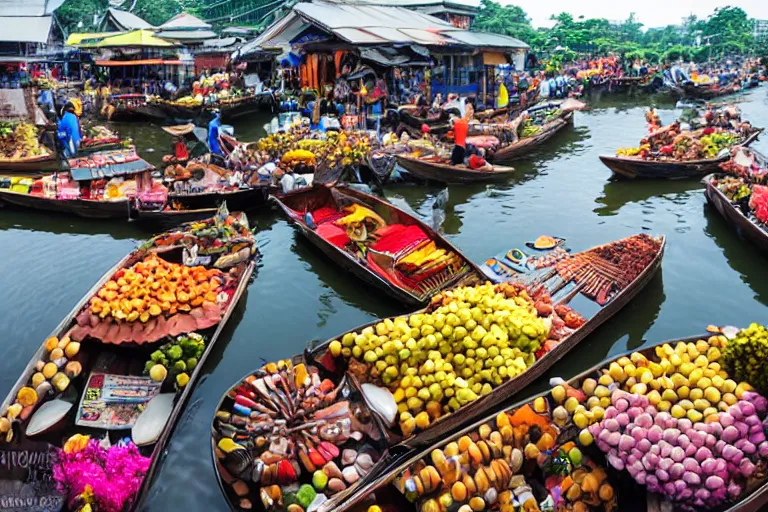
[213,235,664,512]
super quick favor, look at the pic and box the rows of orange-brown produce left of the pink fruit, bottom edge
[394,405,616,512]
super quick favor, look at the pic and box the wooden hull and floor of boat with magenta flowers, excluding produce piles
[0,209,256,512]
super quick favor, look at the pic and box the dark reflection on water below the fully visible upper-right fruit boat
[594,177,703,217]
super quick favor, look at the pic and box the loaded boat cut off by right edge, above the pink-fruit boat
[702,148,768,252]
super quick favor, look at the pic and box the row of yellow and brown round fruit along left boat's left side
[0,336,83,442]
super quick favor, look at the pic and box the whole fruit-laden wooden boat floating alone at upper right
[600,107,762,179]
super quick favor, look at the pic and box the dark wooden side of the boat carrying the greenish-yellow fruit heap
[214,233,664,512]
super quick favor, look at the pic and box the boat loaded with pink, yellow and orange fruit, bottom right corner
[336,324,768,512]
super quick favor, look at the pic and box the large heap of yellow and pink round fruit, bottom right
[534,325,768,509]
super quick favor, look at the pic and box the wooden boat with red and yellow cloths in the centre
[274,186,484,306]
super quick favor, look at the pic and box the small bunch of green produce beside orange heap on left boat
[144,332,205,388]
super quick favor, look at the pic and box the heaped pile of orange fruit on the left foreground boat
[90,254,221,322]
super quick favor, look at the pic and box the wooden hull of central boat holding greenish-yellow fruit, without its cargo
[213,237,664,512]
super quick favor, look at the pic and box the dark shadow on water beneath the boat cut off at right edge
[703,199,768,306]
